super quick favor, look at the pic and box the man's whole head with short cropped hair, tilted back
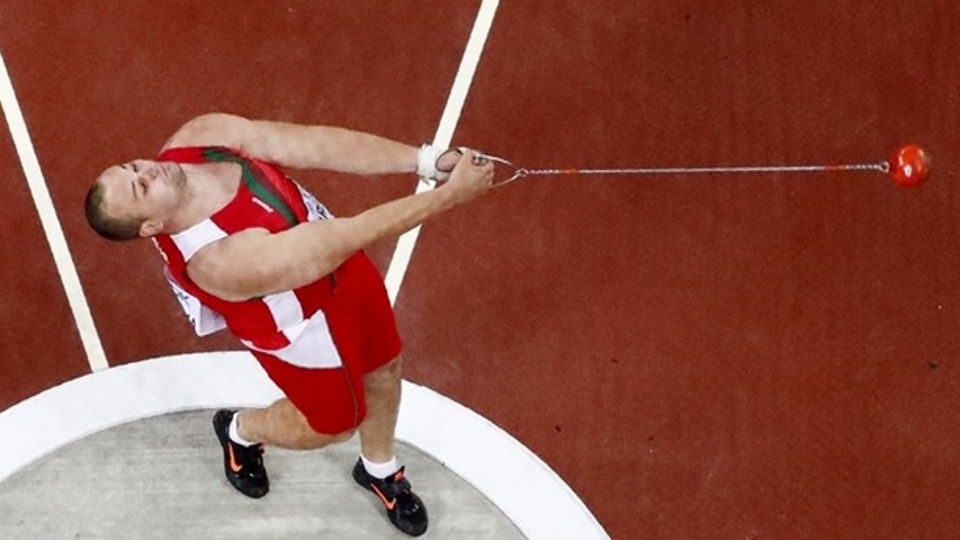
[86,160,186,240]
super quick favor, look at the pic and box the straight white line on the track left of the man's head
[0,48,110,371]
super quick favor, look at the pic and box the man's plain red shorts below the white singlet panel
[250,255,401,435]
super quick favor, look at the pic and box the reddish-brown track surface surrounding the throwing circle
[0,0,960,540]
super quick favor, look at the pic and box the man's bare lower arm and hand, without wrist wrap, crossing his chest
[187,151,493,301]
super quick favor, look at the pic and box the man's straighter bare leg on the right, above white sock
[360,357,402,463]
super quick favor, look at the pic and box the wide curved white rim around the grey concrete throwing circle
[0,351,610,540]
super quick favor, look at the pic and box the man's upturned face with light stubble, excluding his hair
[97,160,185,236]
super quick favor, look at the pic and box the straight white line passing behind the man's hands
[384,0,500,304]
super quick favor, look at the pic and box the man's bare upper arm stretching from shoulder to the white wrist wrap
[164,113,417,174]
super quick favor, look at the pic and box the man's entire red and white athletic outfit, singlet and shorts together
[154,147,401,433]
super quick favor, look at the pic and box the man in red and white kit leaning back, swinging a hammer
[86,114,493,536]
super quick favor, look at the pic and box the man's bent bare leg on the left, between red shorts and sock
[237,398,354,450]
